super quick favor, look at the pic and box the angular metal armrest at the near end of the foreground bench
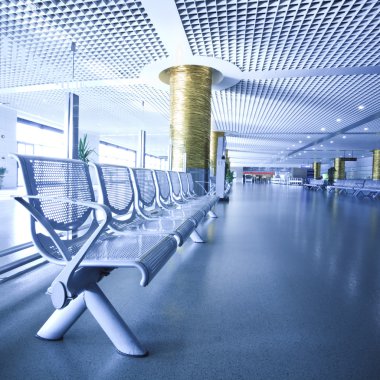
[13,195,112,309]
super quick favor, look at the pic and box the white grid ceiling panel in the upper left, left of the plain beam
[0,0,167,87]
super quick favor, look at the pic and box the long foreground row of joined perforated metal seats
[11,155,218,356]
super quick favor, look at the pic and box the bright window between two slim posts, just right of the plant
[99,141,136,168]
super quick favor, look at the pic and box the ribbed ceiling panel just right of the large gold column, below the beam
[212,75,380,135]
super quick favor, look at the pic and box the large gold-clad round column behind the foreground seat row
[168,65,212,171]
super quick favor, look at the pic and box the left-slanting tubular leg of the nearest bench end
[36,294,86,340]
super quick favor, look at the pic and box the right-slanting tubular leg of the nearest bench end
[84,284,148,357]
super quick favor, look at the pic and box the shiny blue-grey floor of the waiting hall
[0,184,380,379]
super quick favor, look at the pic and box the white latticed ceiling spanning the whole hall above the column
[0,0,380,166]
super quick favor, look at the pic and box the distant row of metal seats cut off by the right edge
[326,179,380,199]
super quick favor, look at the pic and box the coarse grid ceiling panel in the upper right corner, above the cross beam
[176,0,380,71]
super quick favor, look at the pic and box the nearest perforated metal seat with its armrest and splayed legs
[11,155,178,356]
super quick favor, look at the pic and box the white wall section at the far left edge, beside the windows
[0,106,17,189]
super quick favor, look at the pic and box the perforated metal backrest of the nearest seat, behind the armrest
[14,155,99,264]
